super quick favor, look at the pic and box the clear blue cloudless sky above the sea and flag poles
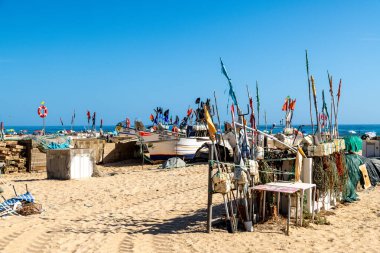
[0,0,380,125]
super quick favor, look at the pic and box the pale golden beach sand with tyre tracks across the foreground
[0,163,380,253]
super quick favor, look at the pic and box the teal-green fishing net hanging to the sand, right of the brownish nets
[343,154,363,202]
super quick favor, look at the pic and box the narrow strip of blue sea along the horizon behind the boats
[5,124,380,136]
